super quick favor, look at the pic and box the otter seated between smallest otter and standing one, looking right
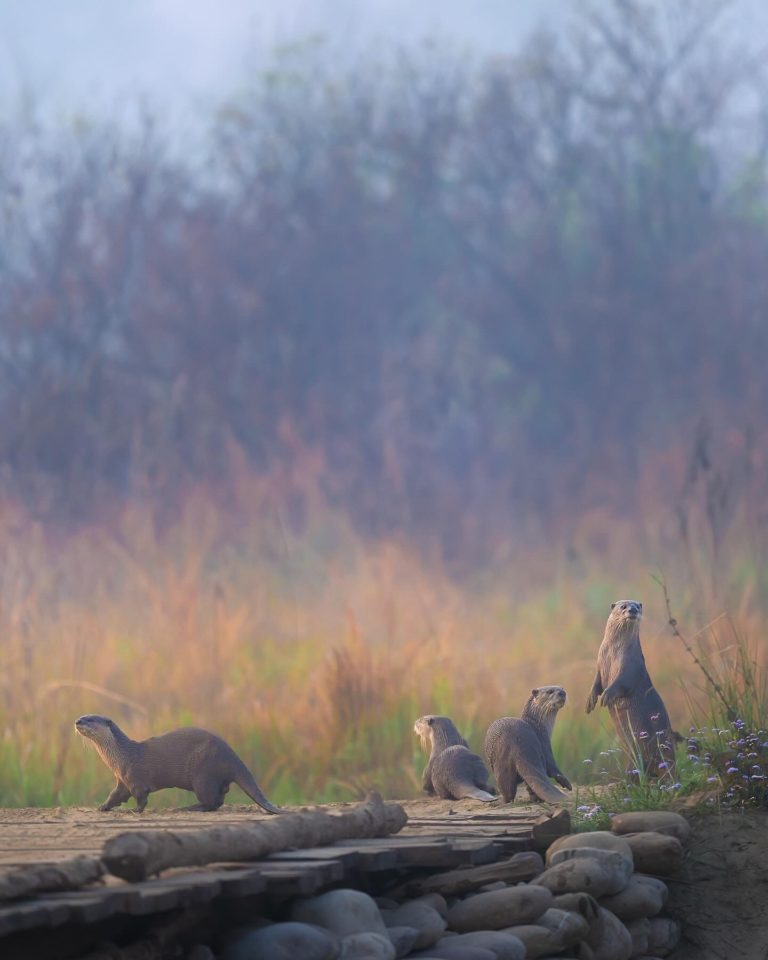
[485,686,573,803]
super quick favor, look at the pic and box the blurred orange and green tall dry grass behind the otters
[0,452,768,806]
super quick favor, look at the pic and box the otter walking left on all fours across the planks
[75,715,283,813]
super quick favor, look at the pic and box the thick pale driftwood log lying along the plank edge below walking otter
[102,793,408,882]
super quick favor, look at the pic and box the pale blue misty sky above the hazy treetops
[0,0,581,115]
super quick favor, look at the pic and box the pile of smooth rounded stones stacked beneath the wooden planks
[222,812,689,960]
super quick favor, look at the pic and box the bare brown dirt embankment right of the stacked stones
[670,811,768,960]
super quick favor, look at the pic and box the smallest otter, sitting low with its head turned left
[413,714,498,803]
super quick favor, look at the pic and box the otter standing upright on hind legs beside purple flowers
[587,600,675,777]
